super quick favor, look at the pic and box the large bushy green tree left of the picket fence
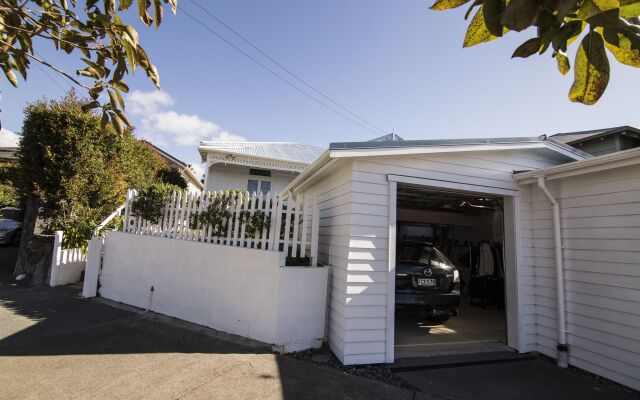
[18,93,180,247]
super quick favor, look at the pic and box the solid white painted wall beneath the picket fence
[100,232,328,351]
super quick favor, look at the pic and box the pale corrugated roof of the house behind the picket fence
[198,141,324,164]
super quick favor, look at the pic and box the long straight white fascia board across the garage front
[331,142,555,158]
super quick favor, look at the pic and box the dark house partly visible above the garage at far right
[551,126,640,156]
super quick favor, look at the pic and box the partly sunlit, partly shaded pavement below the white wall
[0,271,420,400]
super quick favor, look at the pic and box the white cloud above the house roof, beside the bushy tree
[127,90,246,146]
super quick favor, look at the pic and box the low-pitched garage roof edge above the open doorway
[282,135,592,193]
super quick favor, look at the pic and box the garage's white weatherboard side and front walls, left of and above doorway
[296,150,562,364]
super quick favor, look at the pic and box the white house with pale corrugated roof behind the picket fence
[198,141,323,194]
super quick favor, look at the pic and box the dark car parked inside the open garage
[396,241,461,322]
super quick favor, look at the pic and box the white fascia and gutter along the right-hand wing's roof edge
[513,148,640,185]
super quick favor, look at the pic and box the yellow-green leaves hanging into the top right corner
[431,0,640,104]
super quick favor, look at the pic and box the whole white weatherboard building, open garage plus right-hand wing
[283,136,640,388]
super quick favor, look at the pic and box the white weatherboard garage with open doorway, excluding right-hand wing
[285,137,587,365]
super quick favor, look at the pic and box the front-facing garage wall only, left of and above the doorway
[340,150,560,364]
